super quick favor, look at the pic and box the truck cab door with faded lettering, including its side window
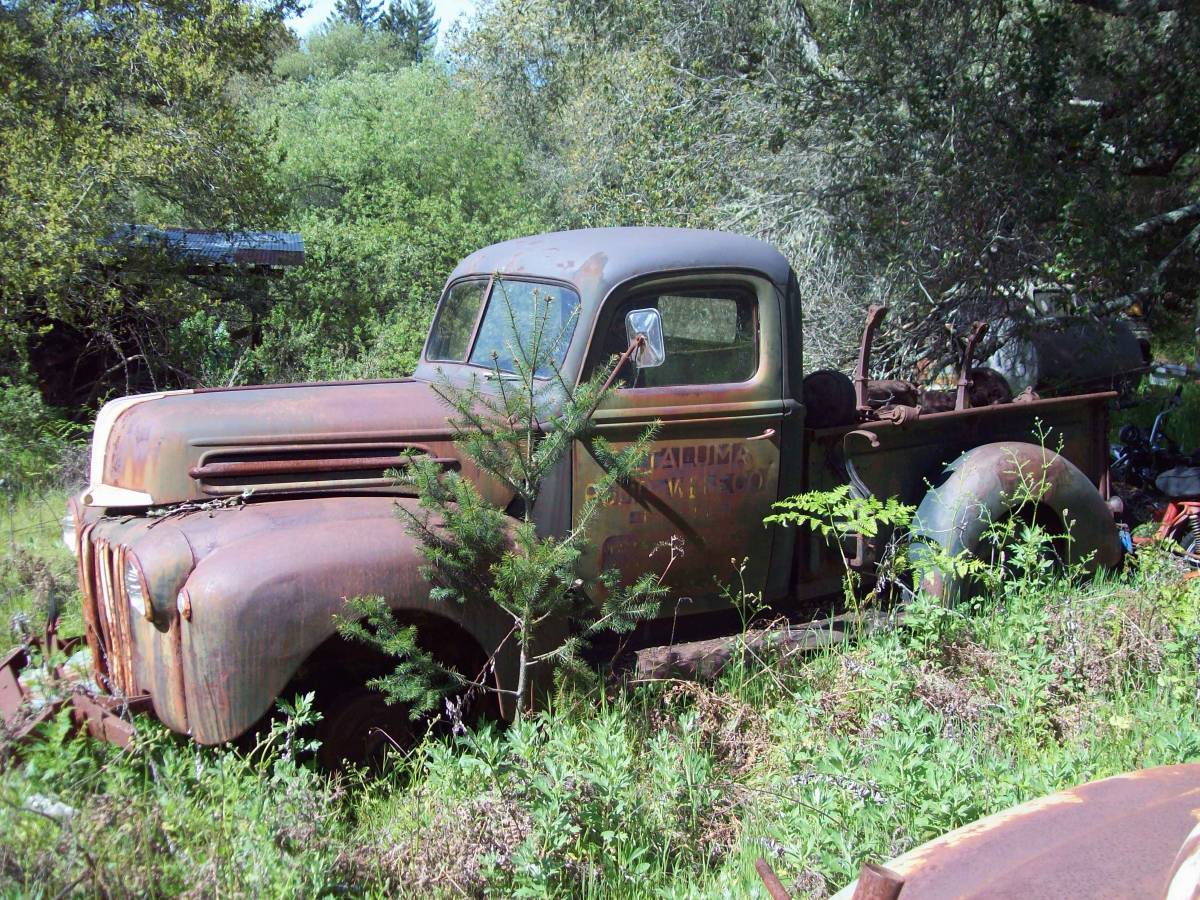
[572,275,786,612]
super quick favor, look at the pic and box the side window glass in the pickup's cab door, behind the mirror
[598,284,758,388]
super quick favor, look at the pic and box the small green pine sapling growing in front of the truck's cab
[338,280,666,719]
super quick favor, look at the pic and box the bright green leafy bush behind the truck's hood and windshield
[253,66,546,380]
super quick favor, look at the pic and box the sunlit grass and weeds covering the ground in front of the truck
[0,496,1200,898]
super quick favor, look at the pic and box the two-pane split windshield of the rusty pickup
[426,278,580,378]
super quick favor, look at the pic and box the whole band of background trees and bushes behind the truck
[9,0,1200,406]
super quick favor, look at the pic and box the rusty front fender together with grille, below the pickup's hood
[78,497,512,744]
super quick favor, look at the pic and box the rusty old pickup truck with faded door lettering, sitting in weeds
[54,228,1121,757]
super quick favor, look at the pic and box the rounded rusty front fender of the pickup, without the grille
[180,497,515,744]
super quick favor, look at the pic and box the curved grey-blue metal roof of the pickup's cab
[450,228,790,299]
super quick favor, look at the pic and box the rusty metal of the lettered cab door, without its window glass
[571,275,799,616]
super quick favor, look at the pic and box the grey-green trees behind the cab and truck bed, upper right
[456,0,1200,371]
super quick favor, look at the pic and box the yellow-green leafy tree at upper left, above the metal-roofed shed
[0,0,295,398]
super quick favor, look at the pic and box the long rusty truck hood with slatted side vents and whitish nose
[84,379,487,508]
